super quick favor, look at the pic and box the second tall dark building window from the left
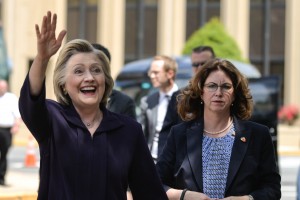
[125,0,158,63]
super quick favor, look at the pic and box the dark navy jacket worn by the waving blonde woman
[19,76,167,200]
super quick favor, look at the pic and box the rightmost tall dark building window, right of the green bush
[249,0,285,78]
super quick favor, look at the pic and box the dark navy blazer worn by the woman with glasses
[156,118,281,200]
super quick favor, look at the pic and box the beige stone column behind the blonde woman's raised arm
[3,0,66,99]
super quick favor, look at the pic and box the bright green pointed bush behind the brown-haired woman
[182,17,247,62]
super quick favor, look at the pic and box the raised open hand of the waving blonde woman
[35,11,66,61]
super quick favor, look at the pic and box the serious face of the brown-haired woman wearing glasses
[201,70,235,114]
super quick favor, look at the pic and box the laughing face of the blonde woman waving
[64,53,105,109]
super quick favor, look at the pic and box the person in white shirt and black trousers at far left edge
[0,80,21,186]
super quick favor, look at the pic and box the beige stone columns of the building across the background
[2,0,300,125]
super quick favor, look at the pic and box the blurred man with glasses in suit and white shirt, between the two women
[141,55,178,160]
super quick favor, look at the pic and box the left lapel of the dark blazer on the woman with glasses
[187,119,203,191]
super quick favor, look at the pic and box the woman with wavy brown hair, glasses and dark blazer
[157,59,281,200]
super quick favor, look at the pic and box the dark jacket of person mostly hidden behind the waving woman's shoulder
[107,89,136,120]
